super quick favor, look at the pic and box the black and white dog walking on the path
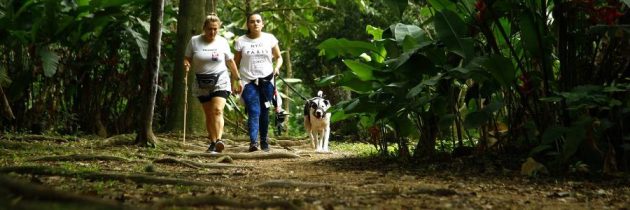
[304,90,330,152]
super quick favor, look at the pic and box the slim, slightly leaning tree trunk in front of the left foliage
[136,0,164,147]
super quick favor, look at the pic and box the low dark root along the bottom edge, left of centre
[157,195,303,209]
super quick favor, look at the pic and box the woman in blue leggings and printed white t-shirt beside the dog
[234,14,282,152]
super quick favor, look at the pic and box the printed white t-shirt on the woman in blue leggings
[234,32,278,81]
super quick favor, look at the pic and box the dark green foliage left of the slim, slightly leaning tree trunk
[0,0,173,135]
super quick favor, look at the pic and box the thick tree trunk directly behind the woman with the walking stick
[166,0,206,134]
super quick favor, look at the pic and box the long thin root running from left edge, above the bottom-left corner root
[0,166,229,187]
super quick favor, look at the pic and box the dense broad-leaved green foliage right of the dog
[318,0,630,174]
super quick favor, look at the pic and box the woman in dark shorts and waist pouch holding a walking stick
[184,14,240,152]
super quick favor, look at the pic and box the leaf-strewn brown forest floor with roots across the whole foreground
[0,135,630,209]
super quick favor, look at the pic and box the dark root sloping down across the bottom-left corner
[0,175,124,209]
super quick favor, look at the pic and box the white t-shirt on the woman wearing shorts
[185,35,234,74]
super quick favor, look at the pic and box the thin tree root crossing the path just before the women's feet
[161,151,300,160]
